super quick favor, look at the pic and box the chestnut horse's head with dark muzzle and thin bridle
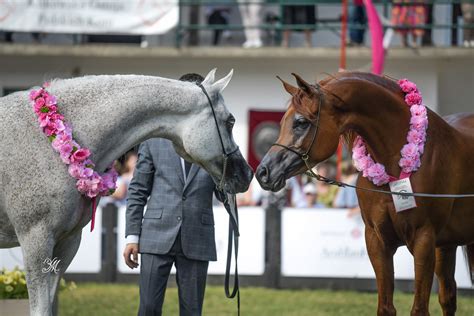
[256,74,340,191]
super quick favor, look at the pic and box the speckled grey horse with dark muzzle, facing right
[0,69,253,315]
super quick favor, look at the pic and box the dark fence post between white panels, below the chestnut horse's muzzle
[264,189,287,289]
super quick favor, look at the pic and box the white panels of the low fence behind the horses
[0,207,473,289]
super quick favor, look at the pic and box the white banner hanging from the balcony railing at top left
[0,0,179,35]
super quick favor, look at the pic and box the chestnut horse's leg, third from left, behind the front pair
[435,247,457,316]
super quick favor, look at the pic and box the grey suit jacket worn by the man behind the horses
[125,138,217,261]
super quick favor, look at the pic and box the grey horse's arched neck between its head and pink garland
[52,76,196,171]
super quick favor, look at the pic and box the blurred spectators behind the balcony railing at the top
[0,0,474,48]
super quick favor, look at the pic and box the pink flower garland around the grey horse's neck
[30,87,118,199]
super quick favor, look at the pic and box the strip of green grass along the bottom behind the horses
[59,283,474,316]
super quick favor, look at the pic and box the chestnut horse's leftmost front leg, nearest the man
[365,225,397,316]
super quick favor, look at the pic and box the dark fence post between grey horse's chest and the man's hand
[100,203,118,283]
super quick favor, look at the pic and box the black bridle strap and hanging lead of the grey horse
[197,83,240,316]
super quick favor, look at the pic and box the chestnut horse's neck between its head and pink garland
[345,82,410,176]
